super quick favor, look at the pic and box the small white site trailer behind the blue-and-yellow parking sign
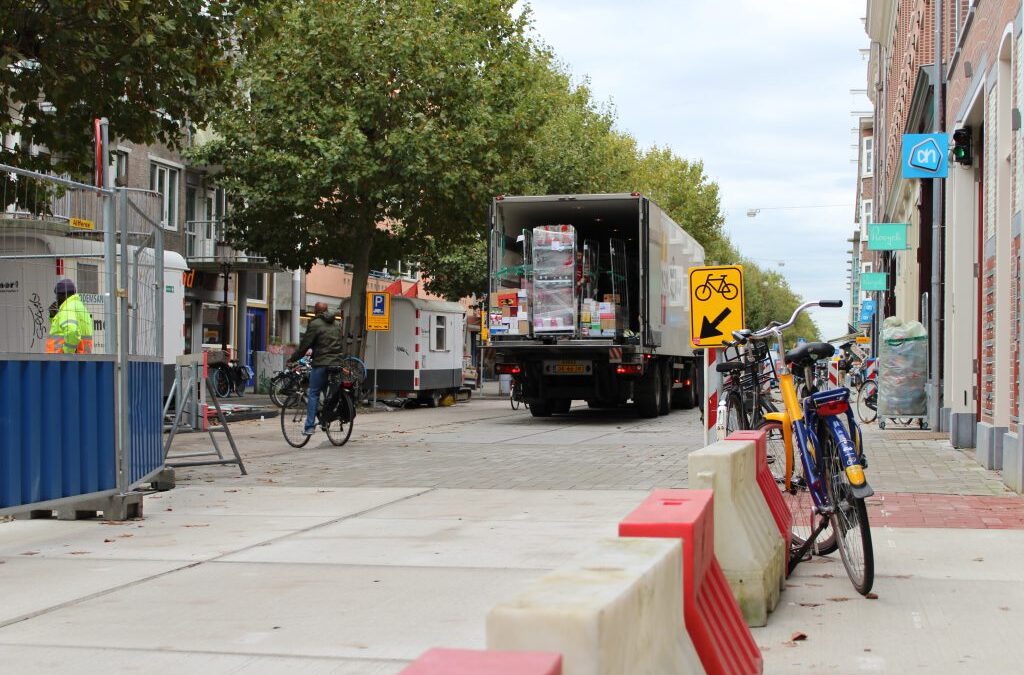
[342,296,466,408]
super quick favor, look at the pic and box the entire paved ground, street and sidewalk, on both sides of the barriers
[0,398,1024,675]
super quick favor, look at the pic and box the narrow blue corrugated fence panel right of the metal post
[128,358,164,487]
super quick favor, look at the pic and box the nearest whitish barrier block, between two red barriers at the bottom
[487,539,705,675]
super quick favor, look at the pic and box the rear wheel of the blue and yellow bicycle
[821,426,874,595]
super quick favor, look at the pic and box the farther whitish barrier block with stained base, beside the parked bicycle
[689,440,786,626]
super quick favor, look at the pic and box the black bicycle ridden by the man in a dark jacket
[281,366,355,448]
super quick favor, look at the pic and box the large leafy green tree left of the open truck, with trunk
[200,0,544,348]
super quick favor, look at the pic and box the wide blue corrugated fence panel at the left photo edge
[0,356,117,510]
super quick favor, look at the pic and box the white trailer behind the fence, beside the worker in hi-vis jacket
[0,230,188,381]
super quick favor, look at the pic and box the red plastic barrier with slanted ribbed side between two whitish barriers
[618,490,764,675]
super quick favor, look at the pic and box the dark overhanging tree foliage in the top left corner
[0,0,255,174]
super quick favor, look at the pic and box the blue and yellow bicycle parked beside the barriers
[751,300,874,594]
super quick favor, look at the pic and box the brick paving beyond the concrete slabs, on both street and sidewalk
[175,391,1024,530]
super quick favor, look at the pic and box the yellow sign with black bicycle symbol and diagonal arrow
[690,265,745,347]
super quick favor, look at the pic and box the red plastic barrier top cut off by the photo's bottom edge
[398,648,562,675]
